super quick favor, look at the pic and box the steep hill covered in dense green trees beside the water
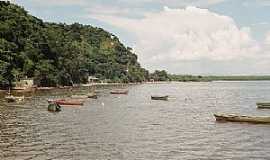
[0,1,148,87]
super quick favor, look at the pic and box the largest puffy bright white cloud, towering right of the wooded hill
[92,7,260,69]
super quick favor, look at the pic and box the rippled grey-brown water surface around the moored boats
[0,81,270,160]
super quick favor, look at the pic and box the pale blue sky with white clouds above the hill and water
[7,0,270,75]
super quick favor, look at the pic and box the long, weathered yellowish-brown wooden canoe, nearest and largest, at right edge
[214,114,270,123]
